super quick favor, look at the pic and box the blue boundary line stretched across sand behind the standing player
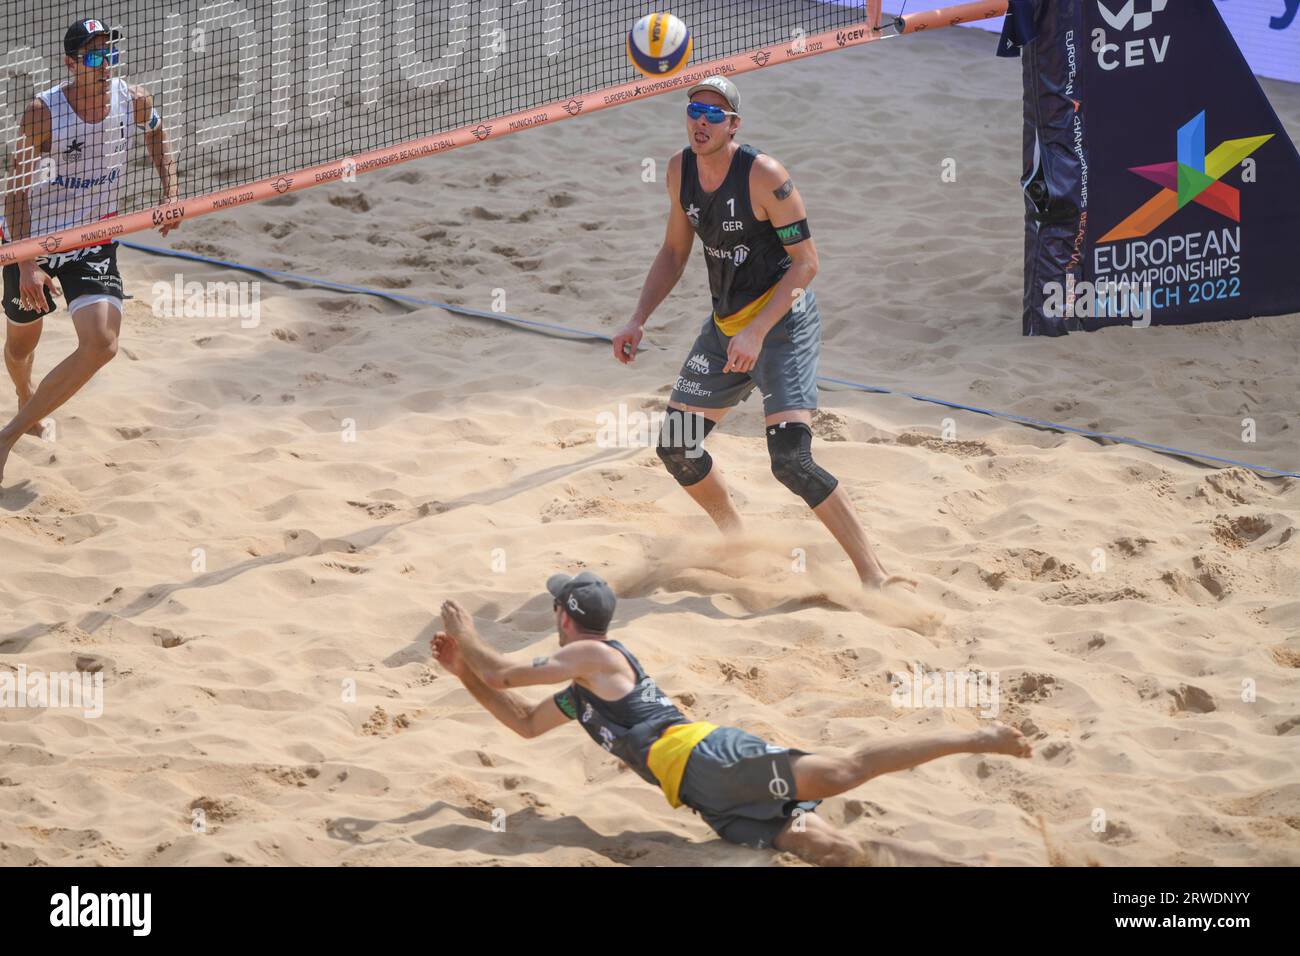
[118,239,1300,477]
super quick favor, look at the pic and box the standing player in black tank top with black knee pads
[614,77,915,588]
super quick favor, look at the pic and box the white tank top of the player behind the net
[29,77,135,237]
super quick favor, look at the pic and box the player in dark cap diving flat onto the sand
[432,571,1031,866]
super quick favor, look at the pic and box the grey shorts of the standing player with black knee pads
[671,289,822,415]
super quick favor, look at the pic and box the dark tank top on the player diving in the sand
[555,641,688,787]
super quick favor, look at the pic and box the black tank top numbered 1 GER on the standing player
[680,146,792,336]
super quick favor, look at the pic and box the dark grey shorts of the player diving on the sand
[677,727,822,849]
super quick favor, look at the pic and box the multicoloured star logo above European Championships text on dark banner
[1100,111,1273,242]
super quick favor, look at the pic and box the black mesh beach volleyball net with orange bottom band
[0,0,880,263]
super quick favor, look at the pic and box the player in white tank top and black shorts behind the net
[0,18,178,480]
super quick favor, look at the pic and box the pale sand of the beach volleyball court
[0,31,1300,865]
